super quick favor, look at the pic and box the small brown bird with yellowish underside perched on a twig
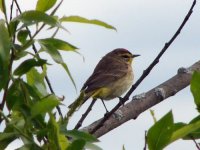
[69,48,140,108]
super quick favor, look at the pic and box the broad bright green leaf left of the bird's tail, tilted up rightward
[31,95,60,117]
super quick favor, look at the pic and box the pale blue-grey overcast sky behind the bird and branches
[1,0,200,150]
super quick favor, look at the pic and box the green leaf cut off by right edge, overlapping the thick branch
[190,71,200,112]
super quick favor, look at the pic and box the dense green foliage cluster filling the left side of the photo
[0,0,115,150]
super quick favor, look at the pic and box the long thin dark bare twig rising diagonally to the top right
[90,0,196,134]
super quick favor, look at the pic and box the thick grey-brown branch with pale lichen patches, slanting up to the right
[82,61,200,137]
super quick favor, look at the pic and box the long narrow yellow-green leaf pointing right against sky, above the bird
[60,16,116,30]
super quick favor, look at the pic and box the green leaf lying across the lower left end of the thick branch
[65,130,99,142]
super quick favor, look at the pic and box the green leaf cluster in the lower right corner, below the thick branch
[147,72,200,150]
